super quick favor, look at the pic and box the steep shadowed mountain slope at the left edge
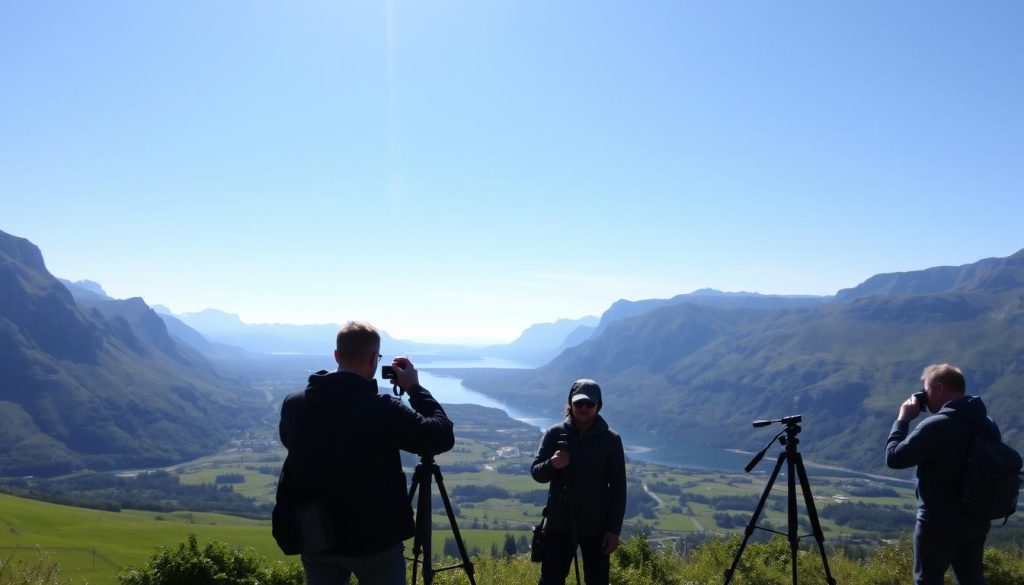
[0,232,269,475]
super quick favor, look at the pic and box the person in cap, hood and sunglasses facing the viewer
[530,379,626,585]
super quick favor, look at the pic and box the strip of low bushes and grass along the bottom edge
[6,535,1024,585]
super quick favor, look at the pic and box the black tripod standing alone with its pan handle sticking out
[725,415,836,585]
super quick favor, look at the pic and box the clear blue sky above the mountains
[0,0,1024,342]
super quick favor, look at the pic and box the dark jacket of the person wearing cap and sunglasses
[530,415,626,536]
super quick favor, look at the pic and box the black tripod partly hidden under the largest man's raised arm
[409,455,476,585]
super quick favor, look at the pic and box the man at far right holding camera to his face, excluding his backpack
[886,364,999,585]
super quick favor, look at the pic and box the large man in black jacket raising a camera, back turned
[273,322,455,585]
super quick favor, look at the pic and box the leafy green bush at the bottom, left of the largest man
[118,534,304,585]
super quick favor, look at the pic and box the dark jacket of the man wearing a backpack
[886,394,999,523]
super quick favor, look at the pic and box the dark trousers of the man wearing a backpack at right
[913,519,989,585]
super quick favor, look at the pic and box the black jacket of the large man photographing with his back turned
[274,371,455,556]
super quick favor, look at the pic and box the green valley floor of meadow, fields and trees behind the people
[6,406,1024,585]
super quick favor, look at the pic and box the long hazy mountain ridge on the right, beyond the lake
[460,251,1024,472]
